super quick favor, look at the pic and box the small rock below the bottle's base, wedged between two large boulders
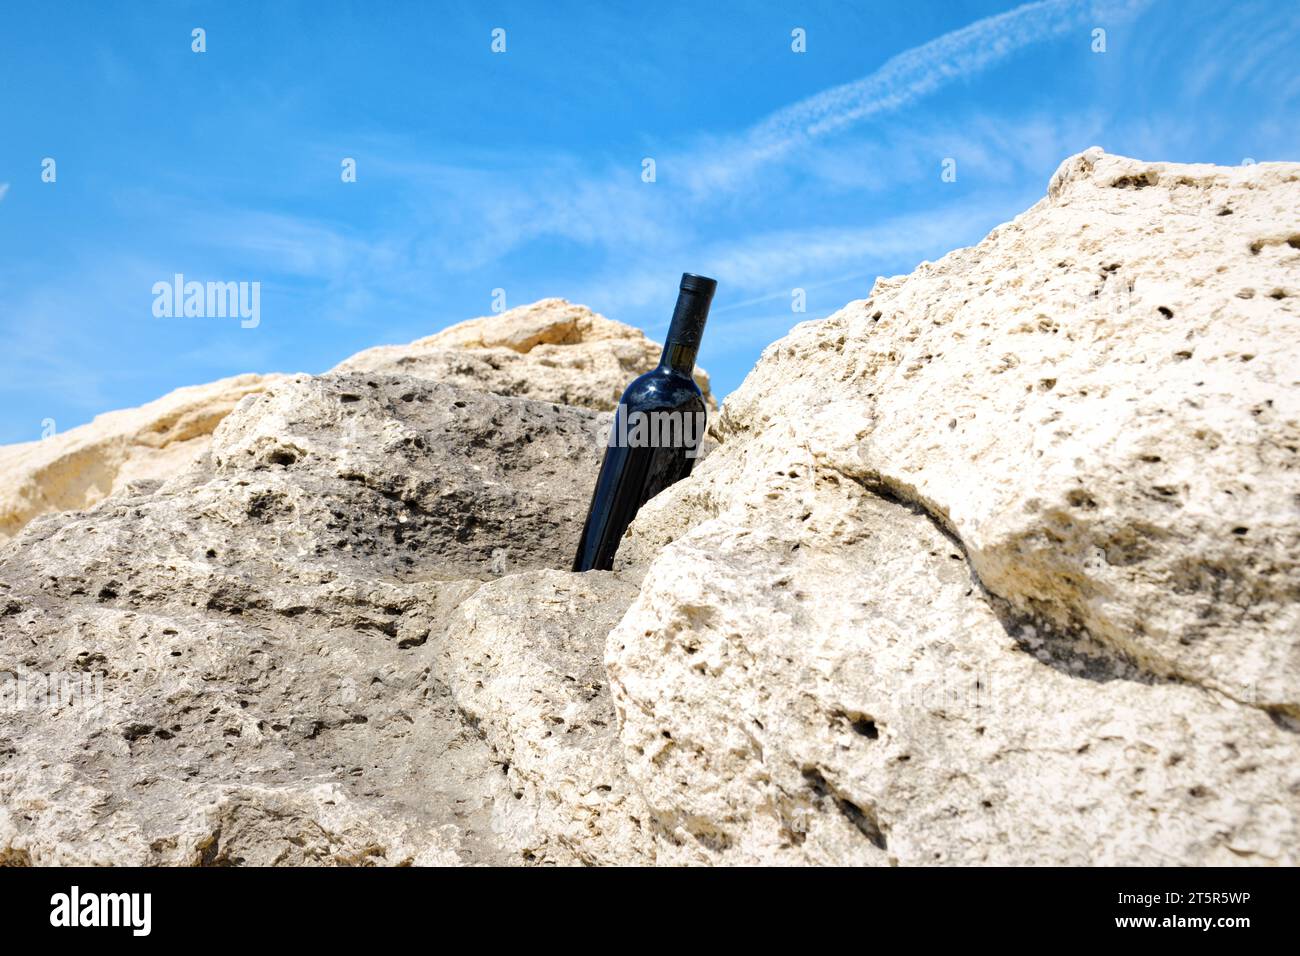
[438,571,655,865]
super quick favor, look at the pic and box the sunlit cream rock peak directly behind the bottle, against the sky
[325,299,718,411]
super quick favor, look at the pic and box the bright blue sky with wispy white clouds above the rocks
[0,0,1300,442]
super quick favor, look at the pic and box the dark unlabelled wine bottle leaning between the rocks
[573,272,718,571]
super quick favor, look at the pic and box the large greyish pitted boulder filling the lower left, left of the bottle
[0,373,618,865]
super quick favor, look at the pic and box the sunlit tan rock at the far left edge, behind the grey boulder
[0,375,281,541]
